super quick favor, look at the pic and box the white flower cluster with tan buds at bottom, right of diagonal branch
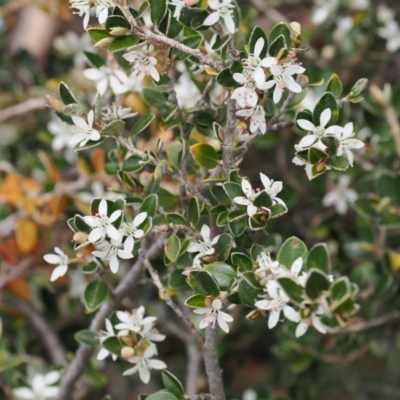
[97,306,167,383]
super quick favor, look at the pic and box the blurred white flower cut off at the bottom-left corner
[12,371,60,400]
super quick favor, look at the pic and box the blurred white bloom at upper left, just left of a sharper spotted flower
[83,66,137,96]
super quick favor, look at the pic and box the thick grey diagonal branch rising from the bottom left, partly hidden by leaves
[56,235,165,400]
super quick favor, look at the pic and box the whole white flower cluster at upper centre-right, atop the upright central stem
[232,38,305,134]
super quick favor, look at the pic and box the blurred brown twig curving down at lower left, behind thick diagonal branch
[13,298,65,364]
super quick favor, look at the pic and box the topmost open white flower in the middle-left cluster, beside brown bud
[83,199,122,243]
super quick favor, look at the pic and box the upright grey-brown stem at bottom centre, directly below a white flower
[203,326,225,400]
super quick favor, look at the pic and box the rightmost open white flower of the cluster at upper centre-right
[265,64,305,104]
